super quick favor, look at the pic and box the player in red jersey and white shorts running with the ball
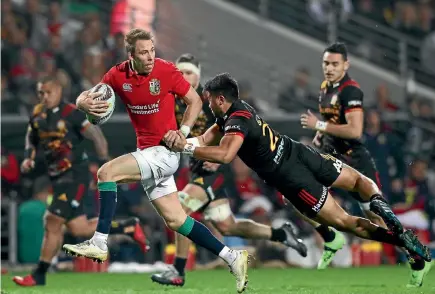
[63,29,252,292]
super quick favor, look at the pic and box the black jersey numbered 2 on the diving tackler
[216,100,292,181]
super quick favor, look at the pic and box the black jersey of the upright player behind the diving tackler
[319,74,364,154]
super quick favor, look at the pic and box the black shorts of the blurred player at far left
[48,169,90,222]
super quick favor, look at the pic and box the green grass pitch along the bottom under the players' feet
[1,267,435,294]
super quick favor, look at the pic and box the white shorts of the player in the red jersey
[131,146,180,201]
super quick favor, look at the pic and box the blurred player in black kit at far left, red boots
[13,77,147,286]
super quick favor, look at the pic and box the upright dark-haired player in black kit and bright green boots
[301,43,431,287]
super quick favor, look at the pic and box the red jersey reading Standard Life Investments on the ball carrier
[101,58,190,149]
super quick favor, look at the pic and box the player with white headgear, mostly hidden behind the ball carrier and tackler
[151,54,307,286]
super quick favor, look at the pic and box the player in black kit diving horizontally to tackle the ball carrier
[165,73,431,276]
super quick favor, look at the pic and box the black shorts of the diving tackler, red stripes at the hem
[274,141,343,217]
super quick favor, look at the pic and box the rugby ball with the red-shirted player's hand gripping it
[76,83,116,125]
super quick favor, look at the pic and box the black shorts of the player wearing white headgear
[189,166,228,210]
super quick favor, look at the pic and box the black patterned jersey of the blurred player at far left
[29,102,90,177]
